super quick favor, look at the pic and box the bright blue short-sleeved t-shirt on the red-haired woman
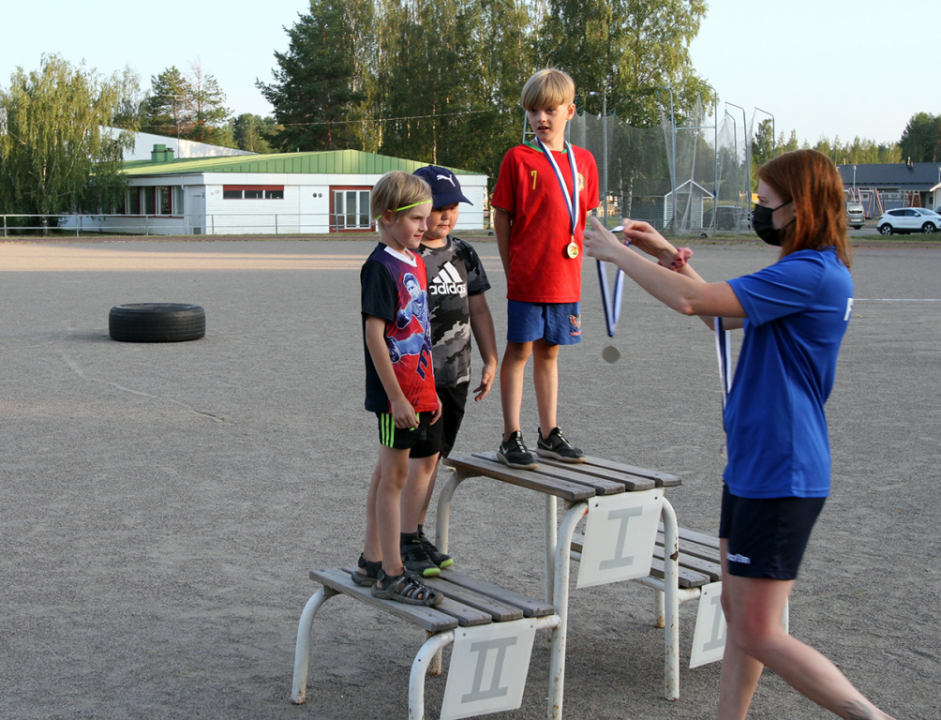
[723,248,853,498]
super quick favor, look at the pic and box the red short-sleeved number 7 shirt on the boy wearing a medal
[491,145,600,303]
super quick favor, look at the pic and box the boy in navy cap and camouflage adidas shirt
[402,165,498,575]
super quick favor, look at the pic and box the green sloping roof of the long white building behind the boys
[124,150,482,176]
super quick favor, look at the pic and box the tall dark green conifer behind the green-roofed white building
[255,0,375,151]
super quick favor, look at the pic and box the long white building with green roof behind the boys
[82,148,487,235]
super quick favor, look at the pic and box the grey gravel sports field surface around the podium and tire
[0,241,941,720]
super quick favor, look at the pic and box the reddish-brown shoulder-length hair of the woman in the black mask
[758,150,853,267]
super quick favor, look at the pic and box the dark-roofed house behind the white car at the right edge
[837,163,941,217]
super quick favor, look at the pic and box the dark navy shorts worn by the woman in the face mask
[719,484,827,580]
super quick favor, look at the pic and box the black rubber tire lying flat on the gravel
[108,303,206,342]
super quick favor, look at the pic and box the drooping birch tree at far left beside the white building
[0,55,136,219]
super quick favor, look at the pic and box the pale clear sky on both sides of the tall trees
[0,0,941,144]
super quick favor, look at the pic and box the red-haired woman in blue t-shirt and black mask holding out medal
[585,150,891,720]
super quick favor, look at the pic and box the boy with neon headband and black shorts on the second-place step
[352,172,443,605]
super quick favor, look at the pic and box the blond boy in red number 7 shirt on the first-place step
[491,69,600,469]
